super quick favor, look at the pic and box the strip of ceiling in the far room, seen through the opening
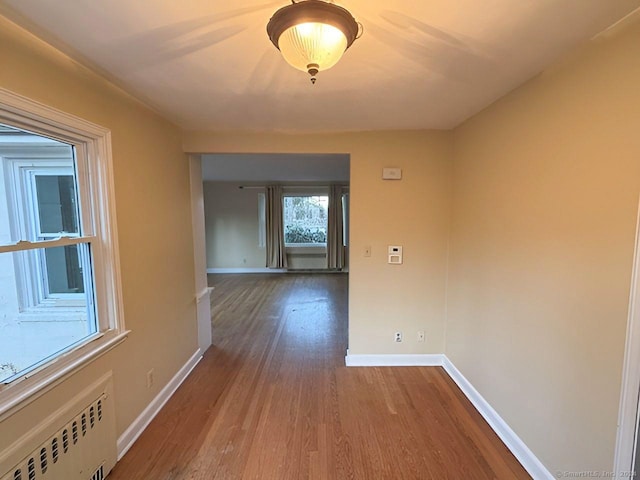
[201,154,349,184]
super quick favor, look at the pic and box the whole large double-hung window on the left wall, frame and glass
[0,90,125,414]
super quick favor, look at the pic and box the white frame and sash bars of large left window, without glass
[0,88,129,421]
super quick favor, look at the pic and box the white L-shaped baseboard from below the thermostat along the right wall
[345,350,555,480]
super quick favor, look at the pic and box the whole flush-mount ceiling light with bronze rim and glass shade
[267,0,362,84]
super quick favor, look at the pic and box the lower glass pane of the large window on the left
[0,244,98,382]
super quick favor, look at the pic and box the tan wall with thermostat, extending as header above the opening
[184,132,451,354]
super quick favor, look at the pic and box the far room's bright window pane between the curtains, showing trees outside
[283,195,329,244]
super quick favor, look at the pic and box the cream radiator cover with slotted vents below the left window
[0,374,116,480]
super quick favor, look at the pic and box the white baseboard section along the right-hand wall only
[442,355,556,480]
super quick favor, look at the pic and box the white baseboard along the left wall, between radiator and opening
[118,349,202,461]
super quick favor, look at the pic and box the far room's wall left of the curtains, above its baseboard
[204,182,266,268]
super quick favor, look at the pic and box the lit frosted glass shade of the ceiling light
[278,22,347,72]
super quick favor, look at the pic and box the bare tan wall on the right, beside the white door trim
[446,17,640,472]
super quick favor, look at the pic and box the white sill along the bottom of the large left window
[0,330,130,422]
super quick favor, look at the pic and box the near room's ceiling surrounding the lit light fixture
[0,0,640,132]
